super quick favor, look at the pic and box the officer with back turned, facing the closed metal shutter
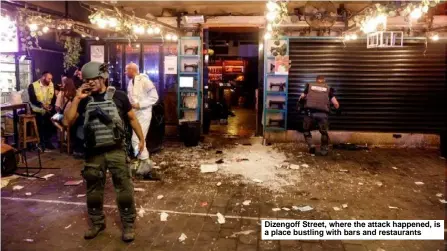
[299,76,340,156]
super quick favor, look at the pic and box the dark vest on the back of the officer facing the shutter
[304,83,329,112]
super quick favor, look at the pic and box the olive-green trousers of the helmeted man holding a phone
[82,149,136,226]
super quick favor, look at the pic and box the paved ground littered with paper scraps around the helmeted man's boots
[1,141,445,251]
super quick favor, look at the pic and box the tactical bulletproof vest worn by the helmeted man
[84,87,124,149]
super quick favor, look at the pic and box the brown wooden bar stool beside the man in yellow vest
[19,114,40,149]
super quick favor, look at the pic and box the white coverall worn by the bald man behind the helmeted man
[127,74,158,160]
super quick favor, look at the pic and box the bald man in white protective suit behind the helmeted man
[126,63,160,180]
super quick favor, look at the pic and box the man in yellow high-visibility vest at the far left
[28,71,56,150]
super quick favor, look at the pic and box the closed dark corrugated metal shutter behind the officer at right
[288,39,447,133]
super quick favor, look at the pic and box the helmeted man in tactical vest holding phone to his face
[64,62,144,242]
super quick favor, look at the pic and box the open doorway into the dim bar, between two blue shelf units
[204,27,259,137]
